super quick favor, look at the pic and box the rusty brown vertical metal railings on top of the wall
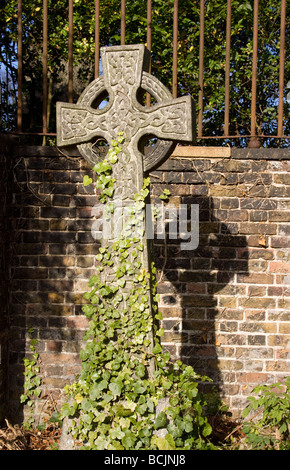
[2,0,289,145]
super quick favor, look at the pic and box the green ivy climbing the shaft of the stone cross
[63,134,213,450]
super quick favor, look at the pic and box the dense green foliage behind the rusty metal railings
[0,0,290,145]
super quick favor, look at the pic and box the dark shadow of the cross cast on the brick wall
[154,197,249,408]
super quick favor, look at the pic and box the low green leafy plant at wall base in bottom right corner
[243,377,290,450]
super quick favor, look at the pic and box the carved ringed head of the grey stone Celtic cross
[57,45,194,173]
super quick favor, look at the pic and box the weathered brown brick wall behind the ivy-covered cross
[4,147,290,416]
